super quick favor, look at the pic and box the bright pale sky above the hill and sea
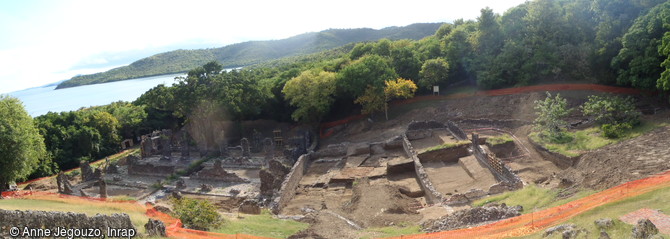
[0,0,525,93]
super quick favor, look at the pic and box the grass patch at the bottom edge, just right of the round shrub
[213,210,309,238]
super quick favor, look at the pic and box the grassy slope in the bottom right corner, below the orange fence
[521,183,670,238]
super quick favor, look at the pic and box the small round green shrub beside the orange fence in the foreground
[172,197,223,231]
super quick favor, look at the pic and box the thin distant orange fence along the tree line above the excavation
[319,84,654,138]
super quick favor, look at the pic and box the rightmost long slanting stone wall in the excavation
[471,134,523,188]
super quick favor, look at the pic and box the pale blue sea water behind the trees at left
[8,74,183,117]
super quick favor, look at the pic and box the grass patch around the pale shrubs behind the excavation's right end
[528,121,667,157]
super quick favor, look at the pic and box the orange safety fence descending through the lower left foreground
[2,190,273,239]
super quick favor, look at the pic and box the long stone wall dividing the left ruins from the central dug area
[271,153,312,214]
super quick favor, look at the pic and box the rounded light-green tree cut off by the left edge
[0,95,47,188]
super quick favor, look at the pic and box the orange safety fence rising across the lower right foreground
[380,171,670,239]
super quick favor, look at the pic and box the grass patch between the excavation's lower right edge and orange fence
[472,184,594,214]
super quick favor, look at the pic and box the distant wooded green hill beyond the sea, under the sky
[56,23,442,89]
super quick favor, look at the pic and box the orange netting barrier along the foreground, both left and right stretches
[2,171,670,239]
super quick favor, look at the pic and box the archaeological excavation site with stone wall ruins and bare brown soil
[5,88,667,238]
